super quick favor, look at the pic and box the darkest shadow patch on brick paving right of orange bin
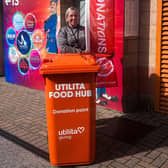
[97,117,155,145]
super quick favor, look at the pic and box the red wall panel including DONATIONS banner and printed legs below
[86,0,124,111]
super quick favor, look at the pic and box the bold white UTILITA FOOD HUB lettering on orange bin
[48,83,92,99]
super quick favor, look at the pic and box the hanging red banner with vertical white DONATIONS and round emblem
[90,0,117,87]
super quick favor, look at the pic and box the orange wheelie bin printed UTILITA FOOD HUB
[40,54,99,166]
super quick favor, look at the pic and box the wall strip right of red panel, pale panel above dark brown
[123,0,139,112]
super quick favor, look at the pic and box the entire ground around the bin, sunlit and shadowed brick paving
[0,77,168,168]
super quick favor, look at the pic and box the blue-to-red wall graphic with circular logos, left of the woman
[3,0,60,90]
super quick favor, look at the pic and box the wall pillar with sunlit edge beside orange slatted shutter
[138,0,157,110]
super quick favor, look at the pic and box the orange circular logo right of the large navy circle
[32,30,44,50]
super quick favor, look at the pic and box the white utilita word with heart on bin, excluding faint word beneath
[58,127,85,136]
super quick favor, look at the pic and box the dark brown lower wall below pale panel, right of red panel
[123,37,138,112]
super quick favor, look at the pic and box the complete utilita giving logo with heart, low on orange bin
[58,126,85,140]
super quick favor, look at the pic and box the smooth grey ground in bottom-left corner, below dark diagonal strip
[0,136,50,168]
